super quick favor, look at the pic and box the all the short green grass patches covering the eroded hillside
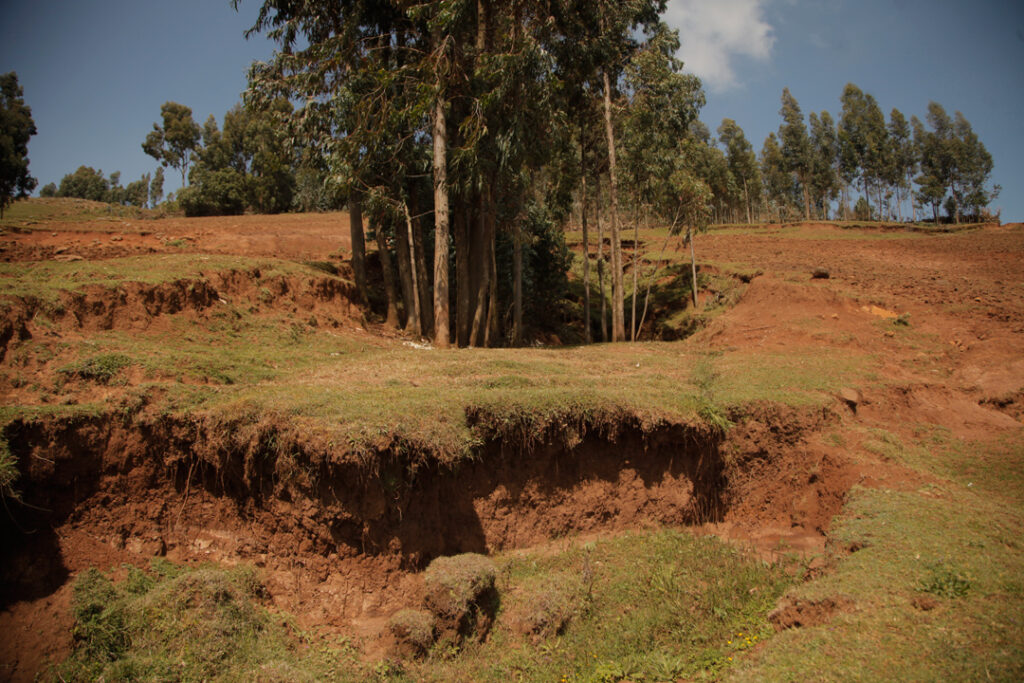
[0,208,1024,680]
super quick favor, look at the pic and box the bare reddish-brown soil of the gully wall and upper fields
[0,214,1024,680]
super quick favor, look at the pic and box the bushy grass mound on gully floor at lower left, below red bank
[44,560,355,683]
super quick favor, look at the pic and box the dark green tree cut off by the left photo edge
[0,72,36,218]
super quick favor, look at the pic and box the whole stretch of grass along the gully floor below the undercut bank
[48,530,793,681]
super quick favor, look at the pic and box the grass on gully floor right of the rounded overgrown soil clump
[382,530,792,682]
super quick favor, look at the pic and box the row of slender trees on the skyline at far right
[749,84,999,223]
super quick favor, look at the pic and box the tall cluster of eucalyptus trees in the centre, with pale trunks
[235,0,724,347]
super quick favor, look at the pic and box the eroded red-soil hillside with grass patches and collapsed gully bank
[0,202,1024,680]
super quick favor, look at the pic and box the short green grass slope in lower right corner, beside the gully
[736,426,1024,681]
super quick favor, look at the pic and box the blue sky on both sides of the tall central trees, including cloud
[6,0,1024,220]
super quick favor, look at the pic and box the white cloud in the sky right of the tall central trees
[664,0,775,90]
